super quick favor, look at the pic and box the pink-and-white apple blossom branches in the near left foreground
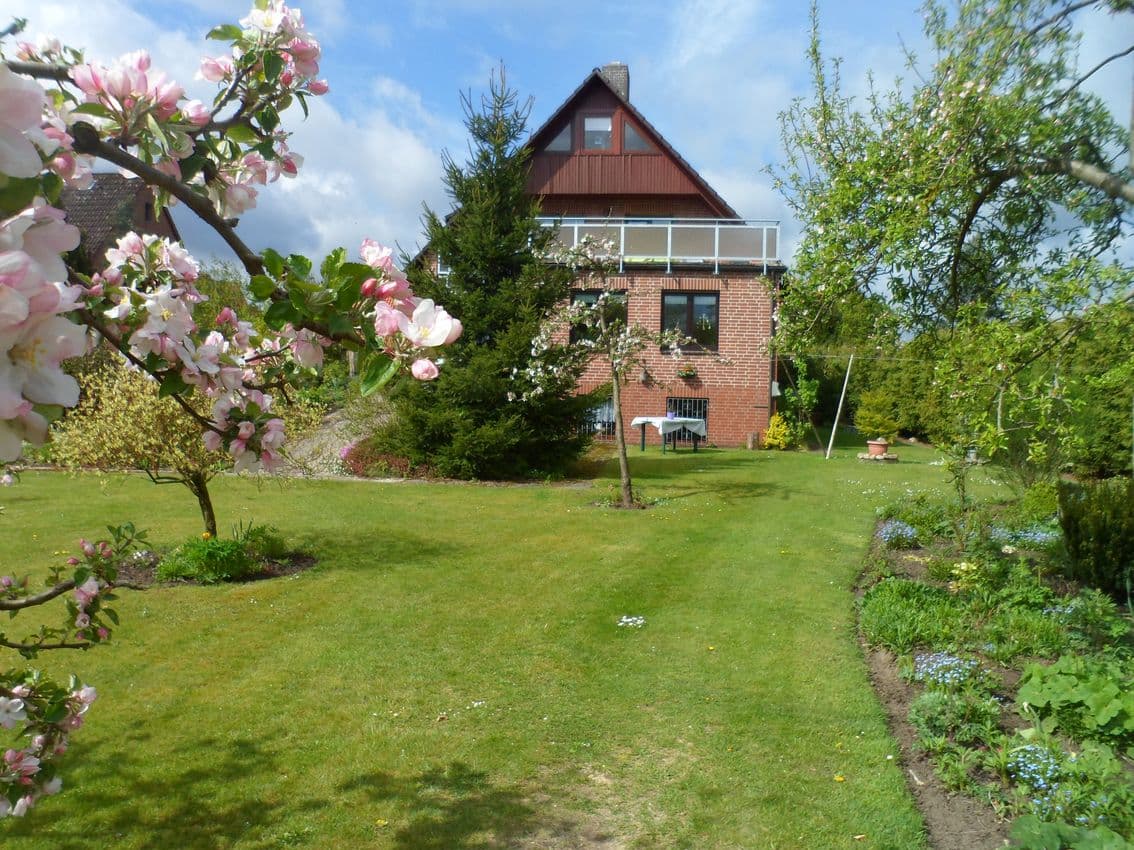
[0,0,462,816]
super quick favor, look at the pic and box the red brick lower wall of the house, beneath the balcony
[560,271,773,447]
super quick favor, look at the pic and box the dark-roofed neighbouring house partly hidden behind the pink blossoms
[59,172,181,271]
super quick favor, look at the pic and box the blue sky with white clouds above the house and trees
[11,0,1131,269]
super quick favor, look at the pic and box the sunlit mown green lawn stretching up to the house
[0,448,984,850]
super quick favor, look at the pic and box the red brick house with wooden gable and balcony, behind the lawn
[528,62,784,447]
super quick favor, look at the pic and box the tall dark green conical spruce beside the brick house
[379,68,595,478]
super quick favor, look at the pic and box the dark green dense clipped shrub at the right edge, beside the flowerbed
[1059,479,1134,603]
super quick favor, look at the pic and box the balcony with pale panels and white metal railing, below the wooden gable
[539,218,780,273]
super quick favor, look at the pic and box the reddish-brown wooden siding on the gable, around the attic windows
[527,85,719,216]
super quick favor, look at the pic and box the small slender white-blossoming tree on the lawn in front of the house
[513,237,692,508]
